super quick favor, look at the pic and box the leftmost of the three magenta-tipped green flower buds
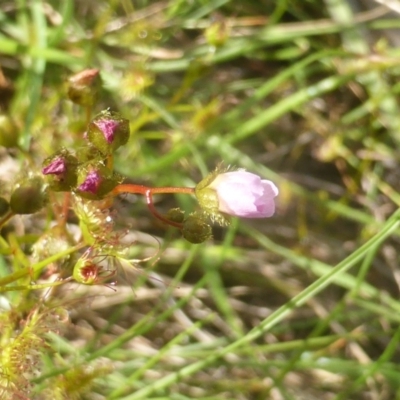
[42,149,78,192]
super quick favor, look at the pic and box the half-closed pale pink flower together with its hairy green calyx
[195,170,279,218]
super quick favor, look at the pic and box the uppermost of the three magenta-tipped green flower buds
[86,110,130,154]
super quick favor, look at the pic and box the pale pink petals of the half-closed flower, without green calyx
[208,170,279,218]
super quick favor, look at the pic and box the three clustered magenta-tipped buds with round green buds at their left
[0,110,130,219]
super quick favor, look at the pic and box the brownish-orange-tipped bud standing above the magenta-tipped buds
[68,69,101,107]
